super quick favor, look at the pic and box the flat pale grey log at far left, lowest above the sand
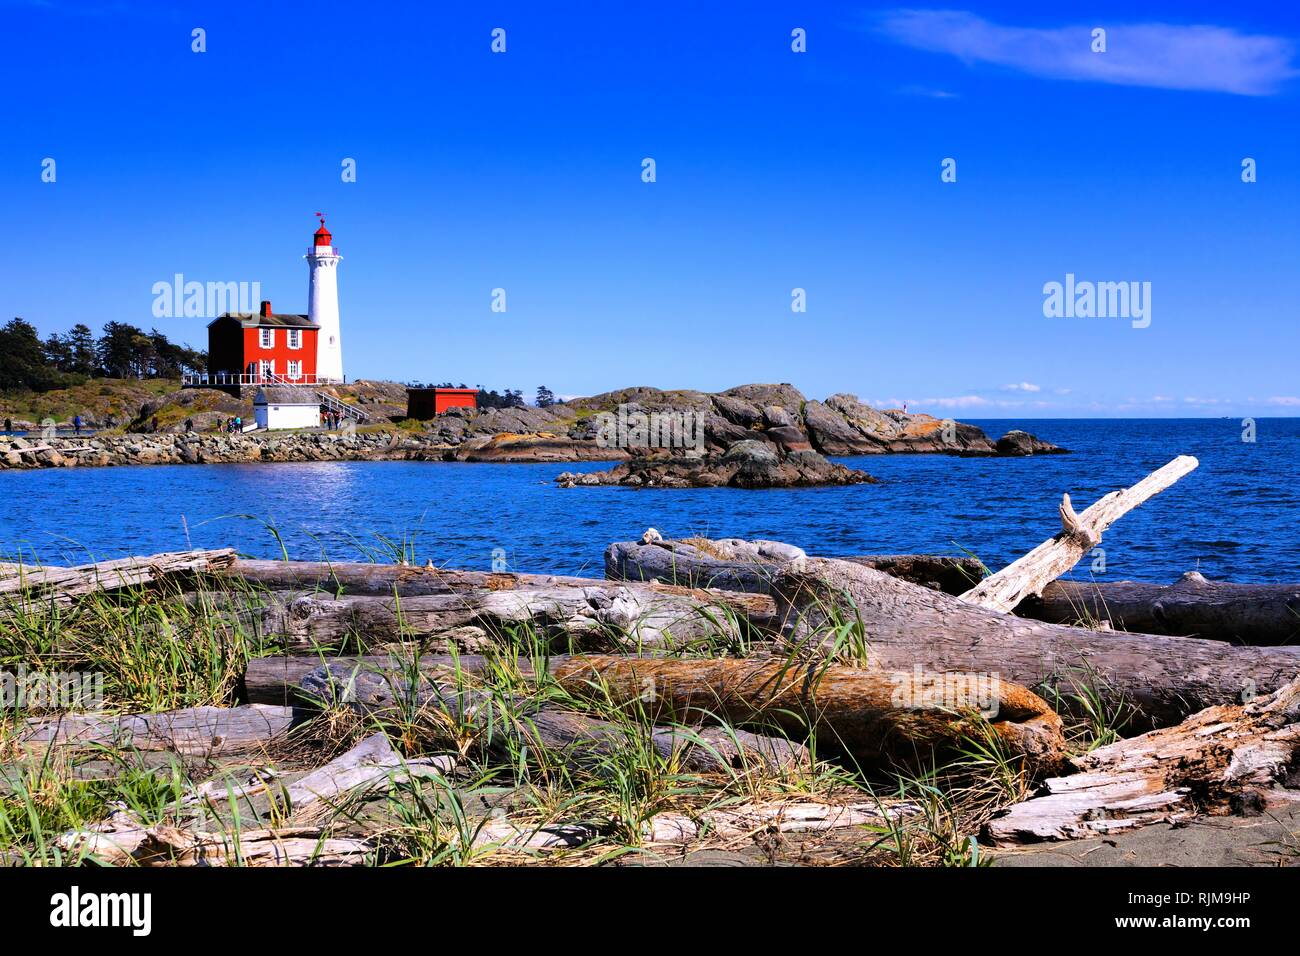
[13,704,295,756]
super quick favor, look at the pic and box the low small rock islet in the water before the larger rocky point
[555,438,876,488]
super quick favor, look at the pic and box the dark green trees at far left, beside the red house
[0,319,208,392]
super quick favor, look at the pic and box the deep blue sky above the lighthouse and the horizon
[0,0,1300,418]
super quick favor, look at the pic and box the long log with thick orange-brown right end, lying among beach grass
[244,656,1063,769]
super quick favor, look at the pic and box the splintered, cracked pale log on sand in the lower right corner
[988,678,1300,844]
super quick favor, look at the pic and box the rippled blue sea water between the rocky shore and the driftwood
[0,419,1300,581]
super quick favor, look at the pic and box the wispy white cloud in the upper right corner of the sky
[881,10,1297,96]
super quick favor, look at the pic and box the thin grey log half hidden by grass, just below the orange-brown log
[298,661,811,773]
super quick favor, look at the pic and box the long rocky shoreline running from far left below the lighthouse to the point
[0,385,1065,470]
